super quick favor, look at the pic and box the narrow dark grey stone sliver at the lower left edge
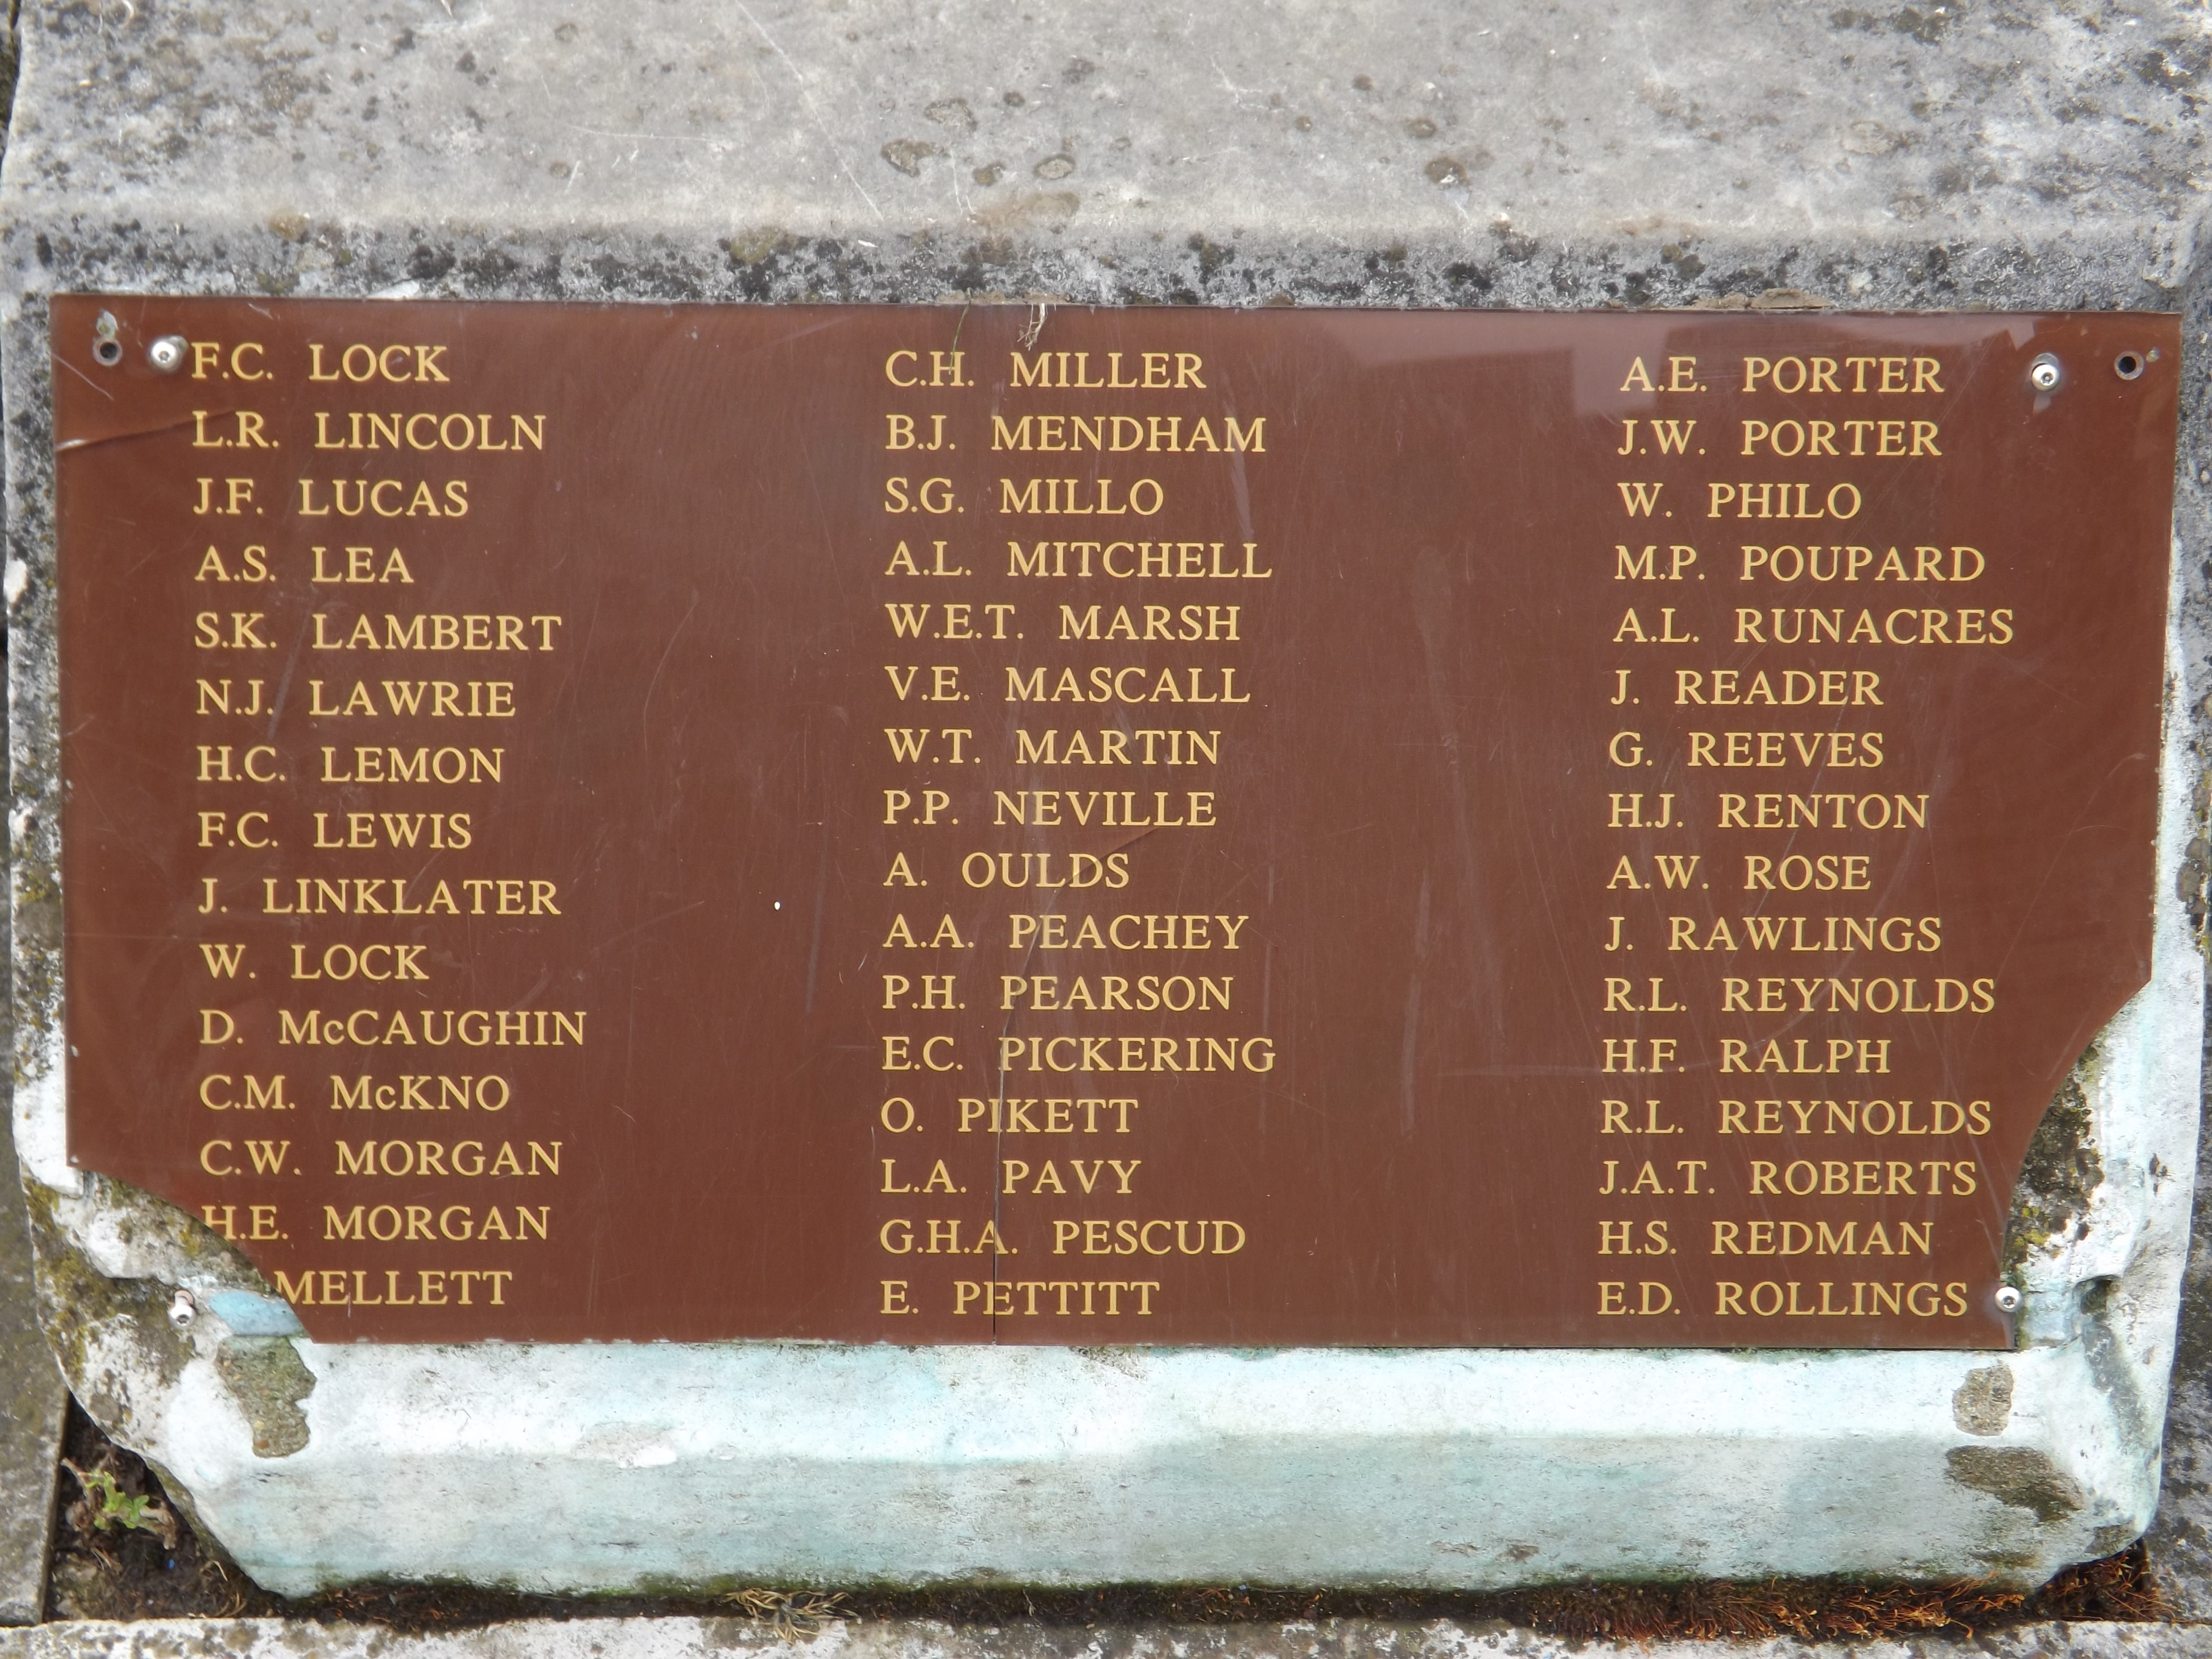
[0,1106,69,1623]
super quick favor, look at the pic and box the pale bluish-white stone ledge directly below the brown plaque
[99,1321,2194,1595]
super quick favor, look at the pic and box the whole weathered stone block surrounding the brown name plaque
[0,0,2212,1610]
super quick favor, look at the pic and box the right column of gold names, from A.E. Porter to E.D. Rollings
[1590,352,2015,1345]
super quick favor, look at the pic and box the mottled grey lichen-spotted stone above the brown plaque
[9,0,2212,307]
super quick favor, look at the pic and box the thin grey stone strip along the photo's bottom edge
[0,1619,2212,1659]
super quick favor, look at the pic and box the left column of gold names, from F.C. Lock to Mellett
[181,325,589,1321]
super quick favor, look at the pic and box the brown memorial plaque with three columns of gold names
[53,297,2181,1347]
